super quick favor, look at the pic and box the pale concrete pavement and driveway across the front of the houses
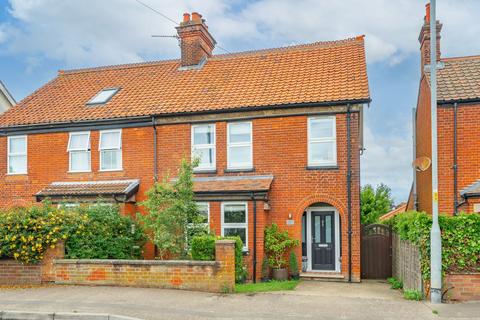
[0,282,480,320]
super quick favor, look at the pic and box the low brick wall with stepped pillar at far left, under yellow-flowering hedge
[0,242,65,285]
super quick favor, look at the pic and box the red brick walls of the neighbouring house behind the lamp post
[416,74,480,215]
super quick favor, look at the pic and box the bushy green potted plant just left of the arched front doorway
[265,223,299,280]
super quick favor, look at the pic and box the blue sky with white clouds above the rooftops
[0,0,480,66]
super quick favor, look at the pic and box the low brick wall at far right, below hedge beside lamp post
[445,273,480,301]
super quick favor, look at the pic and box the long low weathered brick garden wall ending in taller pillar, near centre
[55,240,235,292]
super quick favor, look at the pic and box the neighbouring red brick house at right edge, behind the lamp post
[409,7,480,215]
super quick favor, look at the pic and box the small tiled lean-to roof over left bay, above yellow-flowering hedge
[36,180,140,197]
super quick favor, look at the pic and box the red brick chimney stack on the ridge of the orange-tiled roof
[176,12,217,67]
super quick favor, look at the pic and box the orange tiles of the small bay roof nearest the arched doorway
[193,176,273,193]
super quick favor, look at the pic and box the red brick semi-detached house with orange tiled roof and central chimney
[0,13,370,281]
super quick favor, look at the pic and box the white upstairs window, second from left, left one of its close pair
[67,131,91,172]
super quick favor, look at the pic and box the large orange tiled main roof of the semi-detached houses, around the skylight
[0,36,370,127]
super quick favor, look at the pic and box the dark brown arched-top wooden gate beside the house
[361,224,392,279]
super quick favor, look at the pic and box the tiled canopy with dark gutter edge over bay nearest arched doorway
[193,175,273,201]
